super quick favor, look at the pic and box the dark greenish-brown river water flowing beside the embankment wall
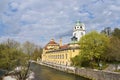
[31,63,89,80]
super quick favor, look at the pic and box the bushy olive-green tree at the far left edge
[0,39,22,71]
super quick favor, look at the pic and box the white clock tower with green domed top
[73,21,85,41]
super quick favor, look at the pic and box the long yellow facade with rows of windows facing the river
[42,49,79,66]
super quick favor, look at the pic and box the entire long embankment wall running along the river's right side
[35,62,120,80]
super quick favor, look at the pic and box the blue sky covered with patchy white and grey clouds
[0,0,120,46]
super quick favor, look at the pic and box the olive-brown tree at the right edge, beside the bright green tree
[105,28,120,70]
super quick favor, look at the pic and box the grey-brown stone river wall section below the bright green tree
[75,68,120,80]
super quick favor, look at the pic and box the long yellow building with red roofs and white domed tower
[42,22,85,66]
